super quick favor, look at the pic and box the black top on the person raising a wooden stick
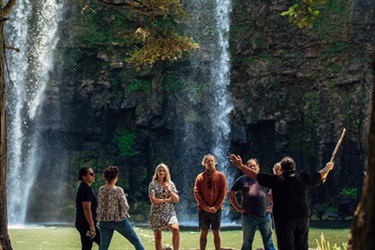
[257,173,321,219]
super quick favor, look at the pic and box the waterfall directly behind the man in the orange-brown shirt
[174,0,234,224]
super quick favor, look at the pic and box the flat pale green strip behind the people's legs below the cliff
[9,225,349,250]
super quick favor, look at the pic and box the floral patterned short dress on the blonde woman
[148,180,178,231]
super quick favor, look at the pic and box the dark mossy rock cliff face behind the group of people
[25,0,375,221]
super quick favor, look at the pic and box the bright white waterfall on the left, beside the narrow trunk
[5,0,64,224]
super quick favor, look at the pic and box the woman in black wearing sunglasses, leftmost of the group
[75,167,100,250]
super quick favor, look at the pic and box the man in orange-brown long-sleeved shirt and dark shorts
[194,154,227,250]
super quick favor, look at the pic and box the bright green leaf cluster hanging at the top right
[281,0,328,28]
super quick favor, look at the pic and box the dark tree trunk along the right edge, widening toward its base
[348,50,375,250]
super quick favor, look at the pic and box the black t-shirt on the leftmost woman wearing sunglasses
[76,182,98,225]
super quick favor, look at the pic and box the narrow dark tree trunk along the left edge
[0,0,15,250]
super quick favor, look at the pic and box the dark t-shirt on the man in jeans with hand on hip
[231,175,268,216]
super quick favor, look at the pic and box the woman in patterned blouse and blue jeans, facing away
[96,166,144,250]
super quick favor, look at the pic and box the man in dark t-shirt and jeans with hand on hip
[228,158,275,250]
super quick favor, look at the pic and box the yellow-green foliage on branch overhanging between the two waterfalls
[72,0,198,70]
